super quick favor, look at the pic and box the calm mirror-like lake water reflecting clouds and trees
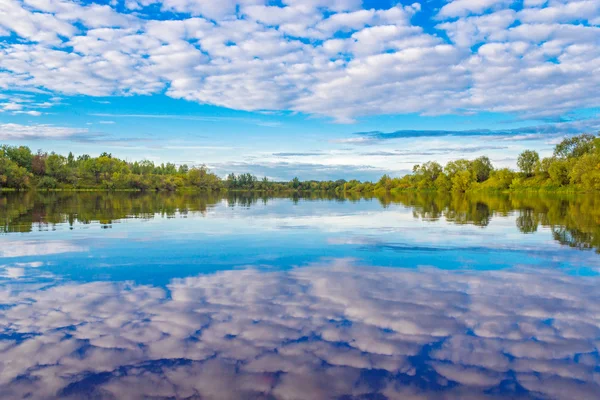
[0,193,600,400]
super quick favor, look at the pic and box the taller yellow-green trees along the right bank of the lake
[375,134,600,192]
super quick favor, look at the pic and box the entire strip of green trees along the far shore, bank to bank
[0,134,600,194]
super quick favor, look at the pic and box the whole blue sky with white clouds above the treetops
[0,0,600,180]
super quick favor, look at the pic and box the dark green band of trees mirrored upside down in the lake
[0,191,600,252]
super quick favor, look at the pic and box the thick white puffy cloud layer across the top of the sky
[0,0,600,122]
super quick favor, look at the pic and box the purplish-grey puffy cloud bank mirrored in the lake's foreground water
[0,259,600,399]
